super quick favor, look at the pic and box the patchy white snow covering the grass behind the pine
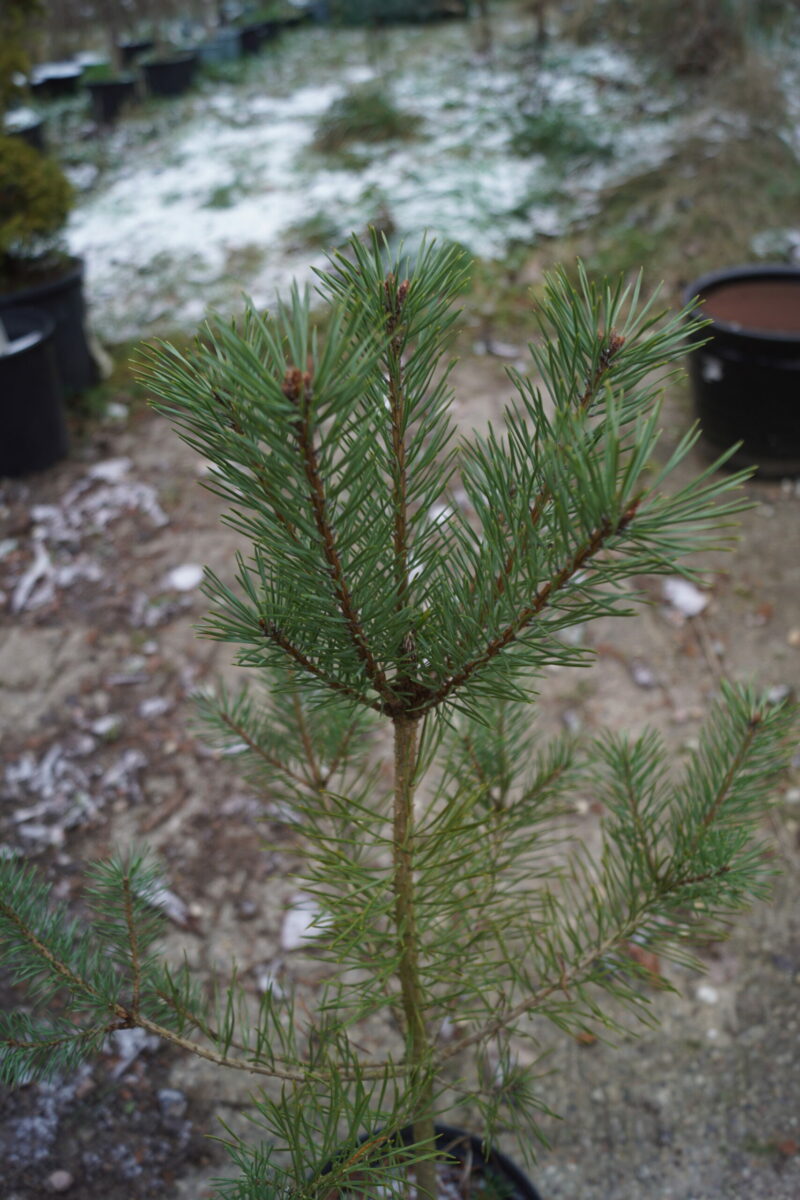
[68,23,672,342]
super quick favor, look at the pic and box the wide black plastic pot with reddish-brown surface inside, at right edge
[686,264,800,478]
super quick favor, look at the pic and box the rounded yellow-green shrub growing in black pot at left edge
[0,138,73,282]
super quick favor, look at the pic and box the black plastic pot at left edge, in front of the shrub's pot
[0,308,67,478]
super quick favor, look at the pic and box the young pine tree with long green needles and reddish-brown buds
[0,240,789,1200]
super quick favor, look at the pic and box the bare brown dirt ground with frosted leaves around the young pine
[0,340,800,1200]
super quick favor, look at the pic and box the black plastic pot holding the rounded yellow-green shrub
[0,258,100,397]
